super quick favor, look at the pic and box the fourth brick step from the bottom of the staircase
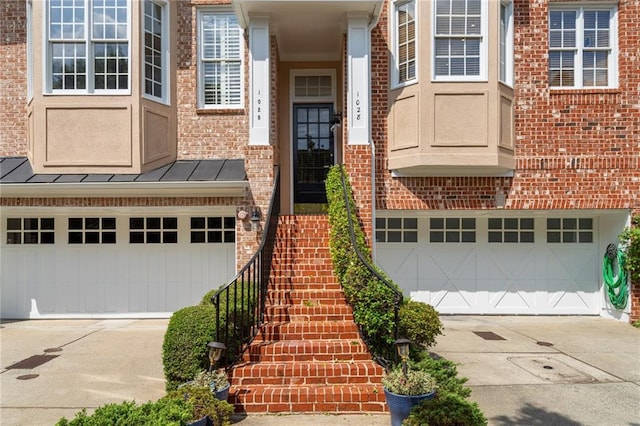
[254,321,360,343]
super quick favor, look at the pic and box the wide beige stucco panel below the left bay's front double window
[44,106,132,166]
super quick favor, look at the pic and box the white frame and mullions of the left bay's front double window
[43,0,132,95]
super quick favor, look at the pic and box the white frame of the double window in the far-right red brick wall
[547,3,618,90]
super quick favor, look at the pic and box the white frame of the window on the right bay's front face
[431,0,491,82]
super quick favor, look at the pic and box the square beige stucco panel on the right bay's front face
[432,93,488,146]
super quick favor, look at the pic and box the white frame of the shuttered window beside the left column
[197,7,245,110]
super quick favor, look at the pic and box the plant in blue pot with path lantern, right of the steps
[382,339,436,426]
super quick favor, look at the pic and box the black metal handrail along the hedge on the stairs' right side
[340,167,403,368]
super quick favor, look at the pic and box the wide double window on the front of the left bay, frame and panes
[47,0,130,93]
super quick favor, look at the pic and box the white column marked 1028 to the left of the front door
[249,16,271,145]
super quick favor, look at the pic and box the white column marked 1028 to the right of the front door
[347,14,371,145]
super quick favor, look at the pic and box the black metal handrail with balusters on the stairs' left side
[211,166,280,367]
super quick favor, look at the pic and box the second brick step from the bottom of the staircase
[229,361,384,387]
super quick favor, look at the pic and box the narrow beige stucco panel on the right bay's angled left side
[389,92,420,151]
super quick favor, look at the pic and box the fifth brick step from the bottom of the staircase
[265,304,353,322]
